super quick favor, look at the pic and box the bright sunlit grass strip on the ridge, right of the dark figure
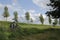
[20,24,60,29]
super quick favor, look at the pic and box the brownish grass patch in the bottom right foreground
[23,31,60,40]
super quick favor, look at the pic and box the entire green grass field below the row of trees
[0,21,60,40]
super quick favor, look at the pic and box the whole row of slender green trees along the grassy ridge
[3,6,57,24]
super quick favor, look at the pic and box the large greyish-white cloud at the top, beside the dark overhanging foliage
[32,0,51,9]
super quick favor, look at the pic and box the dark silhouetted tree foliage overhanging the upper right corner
[46,0,60,23]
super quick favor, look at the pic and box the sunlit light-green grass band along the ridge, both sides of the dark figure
[0,21,60,29]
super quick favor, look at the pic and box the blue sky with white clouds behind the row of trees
[0,0,51,23]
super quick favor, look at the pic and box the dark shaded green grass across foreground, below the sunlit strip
[0,27,60,40]
